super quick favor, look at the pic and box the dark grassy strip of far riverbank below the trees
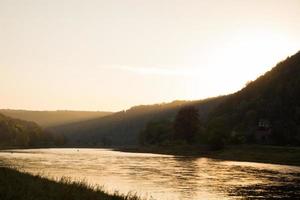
[115,145,300,166]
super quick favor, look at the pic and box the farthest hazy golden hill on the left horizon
[0,109,111,127]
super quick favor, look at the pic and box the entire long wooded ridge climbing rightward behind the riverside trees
[46,52,300,145]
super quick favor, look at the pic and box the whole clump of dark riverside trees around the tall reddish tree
[139,106,224,150]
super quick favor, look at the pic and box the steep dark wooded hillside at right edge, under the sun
[208,52,300,145]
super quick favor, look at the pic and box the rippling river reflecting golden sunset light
[0,149,300,200]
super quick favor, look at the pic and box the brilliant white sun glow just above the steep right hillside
[187,30,298,99]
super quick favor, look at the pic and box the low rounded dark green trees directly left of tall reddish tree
[140,120,173,145]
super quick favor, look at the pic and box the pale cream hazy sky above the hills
[0,0,300,111]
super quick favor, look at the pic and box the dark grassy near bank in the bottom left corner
[0,167,139,200]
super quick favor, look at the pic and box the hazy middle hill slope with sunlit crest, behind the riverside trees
[50,96,226,145]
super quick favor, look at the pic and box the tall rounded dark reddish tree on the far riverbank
[174,106,200,144]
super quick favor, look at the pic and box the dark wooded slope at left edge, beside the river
[0,114,65,147]
